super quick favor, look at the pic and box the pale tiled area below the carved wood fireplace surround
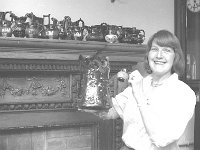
[0,124,98,150]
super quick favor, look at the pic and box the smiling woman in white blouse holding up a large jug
[99,30,196,150]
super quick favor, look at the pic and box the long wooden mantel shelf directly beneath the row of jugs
[0,37,146,62]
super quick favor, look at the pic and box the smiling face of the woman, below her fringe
[148,42,175,76]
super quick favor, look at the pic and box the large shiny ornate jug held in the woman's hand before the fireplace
[79,55,110,110]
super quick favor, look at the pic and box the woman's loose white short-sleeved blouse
[112,73,196,150]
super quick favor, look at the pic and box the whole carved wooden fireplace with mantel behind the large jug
[0,38,146,150]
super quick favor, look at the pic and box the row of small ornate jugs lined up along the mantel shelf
[0,11,145,44]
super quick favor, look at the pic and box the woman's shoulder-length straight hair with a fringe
[145,30,185,76]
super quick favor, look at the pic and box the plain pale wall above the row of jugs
[0,0,174,43]
